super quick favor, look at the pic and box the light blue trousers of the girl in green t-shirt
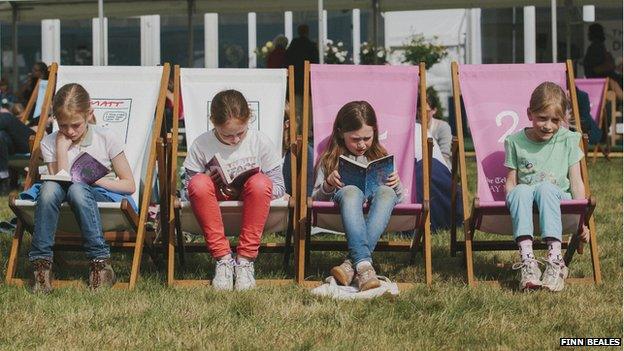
[506,182,572,241]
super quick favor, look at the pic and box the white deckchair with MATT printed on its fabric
[6,64,169,289]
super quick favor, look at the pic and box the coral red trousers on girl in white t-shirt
[188,173,273,258]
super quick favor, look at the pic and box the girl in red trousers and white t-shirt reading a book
[184,90,285,291]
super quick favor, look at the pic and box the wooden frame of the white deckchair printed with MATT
[6,63,170,289]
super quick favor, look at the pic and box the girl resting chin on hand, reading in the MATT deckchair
[29,83,136,292]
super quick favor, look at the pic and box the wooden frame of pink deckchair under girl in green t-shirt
[451,60,602,286]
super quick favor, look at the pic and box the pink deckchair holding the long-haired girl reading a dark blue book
[295,63,433,284]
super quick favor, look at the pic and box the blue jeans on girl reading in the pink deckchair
[333,185,398,265]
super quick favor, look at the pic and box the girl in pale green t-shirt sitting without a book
[505,82,589,291]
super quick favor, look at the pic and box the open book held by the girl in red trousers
[206,153,260,188]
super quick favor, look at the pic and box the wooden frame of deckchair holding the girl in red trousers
[164,65,301,287]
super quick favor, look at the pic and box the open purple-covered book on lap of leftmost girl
[41,151,108,184]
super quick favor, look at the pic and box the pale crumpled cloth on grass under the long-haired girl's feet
[311,276,399,300]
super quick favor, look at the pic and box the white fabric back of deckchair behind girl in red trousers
[180,68,287,154]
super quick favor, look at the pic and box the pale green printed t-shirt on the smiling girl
[505,128,583,193]
